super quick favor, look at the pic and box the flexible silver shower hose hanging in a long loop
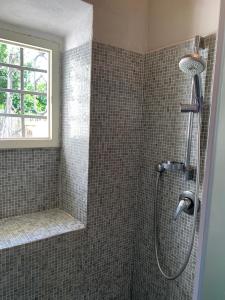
[154,112,201,280]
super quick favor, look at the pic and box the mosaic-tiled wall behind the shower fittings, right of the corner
[133,36,215,300]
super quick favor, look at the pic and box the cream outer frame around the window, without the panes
[0,28,60,149]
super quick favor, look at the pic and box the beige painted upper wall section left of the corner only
[88,0,149,53]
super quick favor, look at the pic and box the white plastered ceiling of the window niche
[0,0,90,37]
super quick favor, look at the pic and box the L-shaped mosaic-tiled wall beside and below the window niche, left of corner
[0,43,143,300]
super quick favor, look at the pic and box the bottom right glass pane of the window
[24,118,48,138]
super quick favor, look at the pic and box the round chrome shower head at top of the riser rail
[179,53,205,76]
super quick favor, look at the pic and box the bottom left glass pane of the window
[0,116,22,139]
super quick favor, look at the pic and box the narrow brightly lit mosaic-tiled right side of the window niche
[60,43,92,223]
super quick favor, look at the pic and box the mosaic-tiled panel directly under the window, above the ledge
[0,148,59,218]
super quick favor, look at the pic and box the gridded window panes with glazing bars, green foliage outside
[0,40,51,140]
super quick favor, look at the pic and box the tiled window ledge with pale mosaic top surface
[0,208,84,249]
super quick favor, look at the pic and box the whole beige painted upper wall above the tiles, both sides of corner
[87,0,220,53]
